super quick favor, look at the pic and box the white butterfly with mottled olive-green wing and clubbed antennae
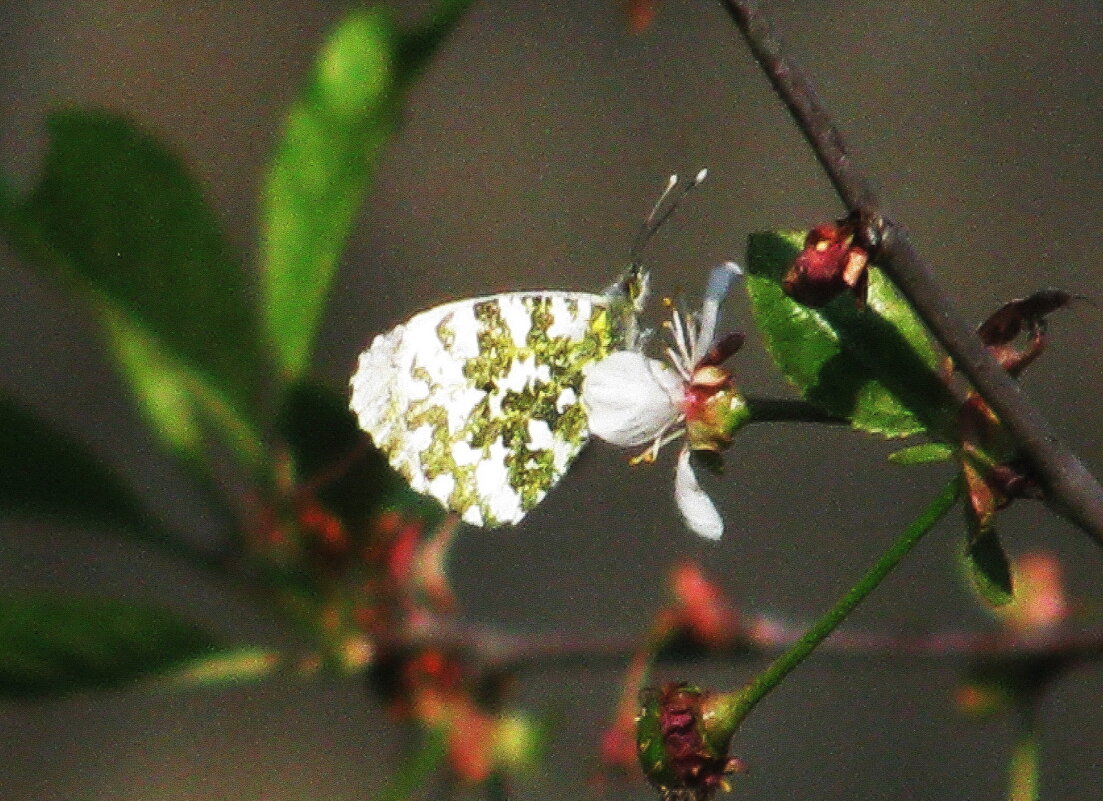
[350,170,705,527]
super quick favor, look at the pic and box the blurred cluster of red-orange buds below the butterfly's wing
[250,436,538,783]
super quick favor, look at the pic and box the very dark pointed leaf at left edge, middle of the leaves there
[0,397,161,540]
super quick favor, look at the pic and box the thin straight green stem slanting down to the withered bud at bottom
[716,477,961,731]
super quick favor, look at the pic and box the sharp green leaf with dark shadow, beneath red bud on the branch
[747,232,954,438]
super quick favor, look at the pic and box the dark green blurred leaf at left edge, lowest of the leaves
[0,594,216,697]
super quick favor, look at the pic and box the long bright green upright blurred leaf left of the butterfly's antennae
[260,0,470,380]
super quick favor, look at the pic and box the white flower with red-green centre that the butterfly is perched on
[582,261,748,540]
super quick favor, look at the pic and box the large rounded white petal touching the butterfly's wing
[582,351,682,448]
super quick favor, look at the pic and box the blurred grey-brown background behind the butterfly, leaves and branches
[0,0,1103,801]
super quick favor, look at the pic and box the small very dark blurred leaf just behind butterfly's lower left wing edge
[278,382,443,531]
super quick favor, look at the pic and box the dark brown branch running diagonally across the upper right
[724,0,1103,545]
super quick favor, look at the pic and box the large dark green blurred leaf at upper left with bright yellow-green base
[4,110,263,470]
